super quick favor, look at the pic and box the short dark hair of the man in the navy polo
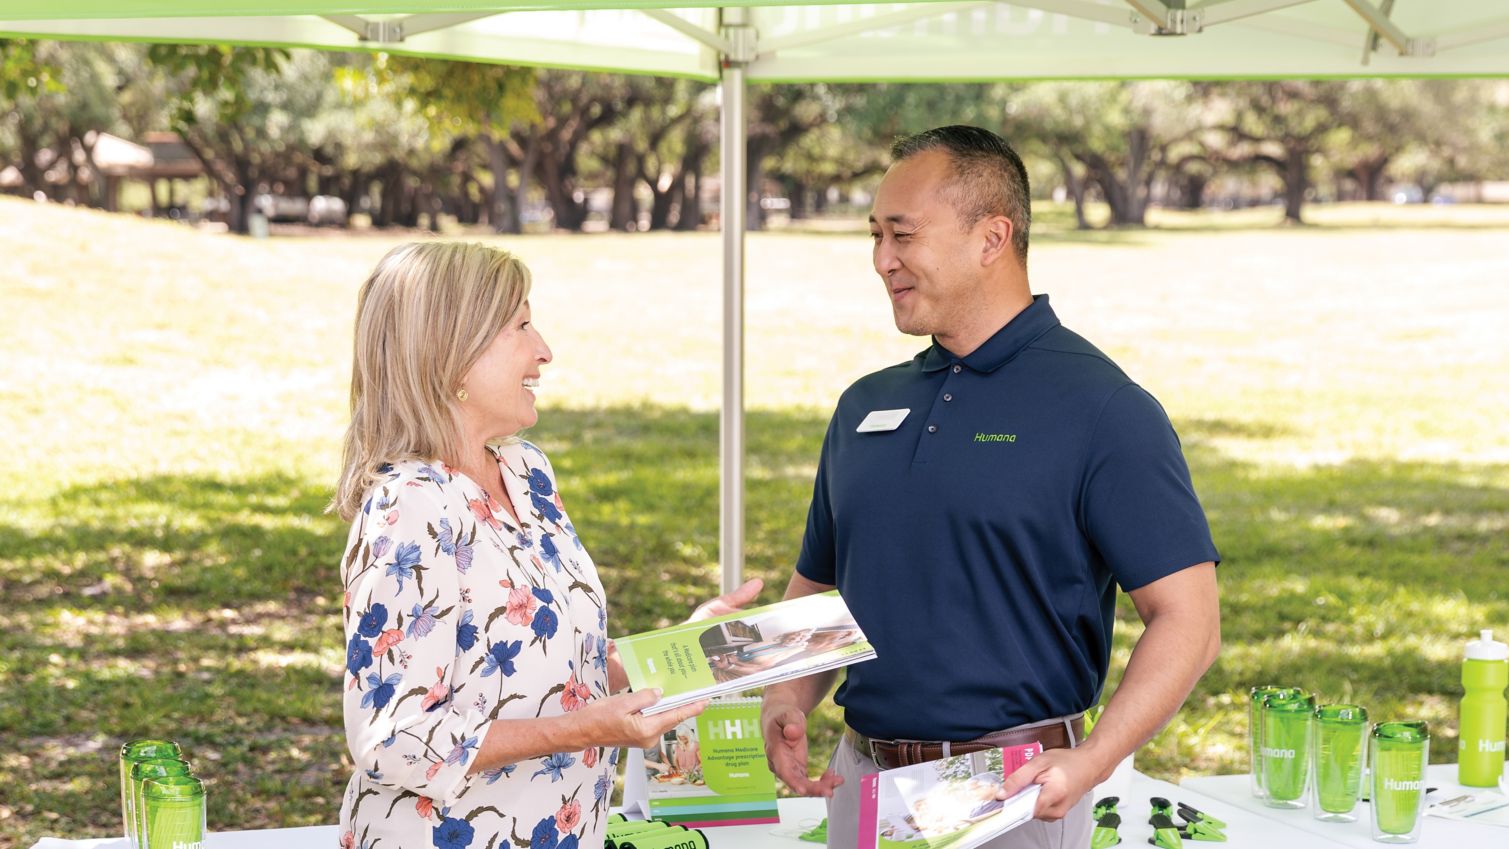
[890,124,1032,265]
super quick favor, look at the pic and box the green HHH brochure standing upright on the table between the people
[623,698,780,828]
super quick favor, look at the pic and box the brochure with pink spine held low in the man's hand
[857,743,1043,849]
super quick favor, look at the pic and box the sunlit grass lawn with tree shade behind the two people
[0,199,1509,849]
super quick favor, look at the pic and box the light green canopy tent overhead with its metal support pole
[0,0,1509,588]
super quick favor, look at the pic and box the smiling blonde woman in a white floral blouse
[333,243,759,849]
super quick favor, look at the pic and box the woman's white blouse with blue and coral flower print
[340,442,619,849]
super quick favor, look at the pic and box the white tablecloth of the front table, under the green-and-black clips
[32,772,1370,849]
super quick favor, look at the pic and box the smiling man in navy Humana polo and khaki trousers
[762,127,1221,849]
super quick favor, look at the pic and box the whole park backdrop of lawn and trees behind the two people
[0,41,1509,847]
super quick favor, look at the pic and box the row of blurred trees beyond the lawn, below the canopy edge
[0,39,1509,232]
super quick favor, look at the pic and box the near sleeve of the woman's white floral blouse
[344,480,492,804]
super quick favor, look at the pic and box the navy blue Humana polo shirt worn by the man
[797,296,1219,740]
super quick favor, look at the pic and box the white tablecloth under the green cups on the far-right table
[1182,763,1509,849]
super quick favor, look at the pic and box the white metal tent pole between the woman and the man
[718,9,747,593]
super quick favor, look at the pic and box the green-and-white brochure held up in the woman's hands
[614,590,875,713]
